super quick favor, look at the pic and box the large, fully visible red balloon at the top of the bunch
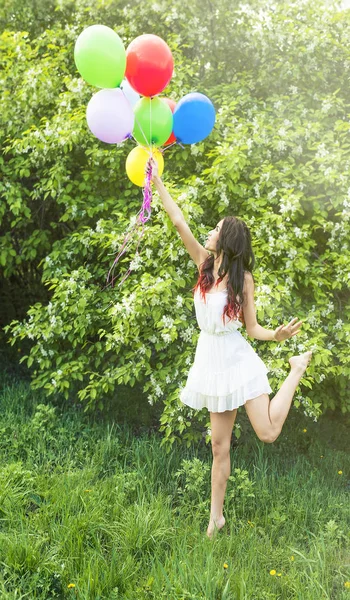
[125,33,174,97]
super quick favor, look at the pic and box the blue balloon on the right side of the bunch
[173,92,215,144]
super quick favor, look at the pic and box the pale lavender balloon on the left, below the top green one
[86,88,135,144]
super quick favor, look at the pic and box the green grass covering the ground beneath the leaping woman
[0,366,350,600]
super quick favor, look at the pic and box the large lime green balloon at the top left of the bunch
[74,25,126,88]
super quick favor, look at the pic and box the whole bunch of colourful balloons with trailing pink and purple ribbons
[74,25,215,285]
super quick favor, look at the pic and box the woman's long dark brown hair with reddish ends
[192,217,255,324]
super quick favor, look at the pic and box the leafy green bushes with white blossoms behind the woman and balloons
[0,0,350,452]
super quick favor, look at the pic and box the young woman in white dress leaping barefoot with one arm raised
[151,160,312,538]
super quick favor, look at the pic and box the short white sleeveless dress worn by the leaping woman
[180,288,272,412]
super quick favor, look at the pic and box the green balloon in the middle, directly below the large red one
[133,97,173,146]
